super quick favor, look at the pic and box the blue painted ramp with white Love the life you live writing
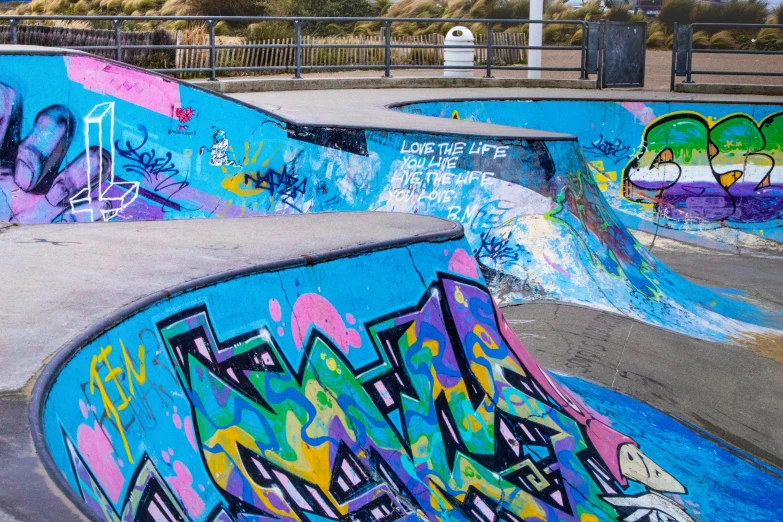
[0,46,783,344]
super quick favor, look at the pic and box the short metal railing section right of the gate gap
[671,22,783,90]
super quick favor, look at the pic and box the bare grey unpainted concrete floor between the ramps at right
[503,242,783,469]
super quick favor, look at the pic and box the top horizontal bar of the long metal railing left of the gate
[0,15,584,25]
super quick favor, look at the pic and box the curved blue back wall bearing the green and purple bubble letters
[400,99,783,252]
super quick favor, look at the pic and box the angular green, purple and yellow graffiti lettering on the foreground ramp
[49,262,692,522]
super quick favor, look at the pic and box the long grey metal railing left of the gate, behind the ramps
[0,15,589,81]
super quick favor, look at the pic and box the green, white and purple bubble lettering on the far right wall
[623,112,783,222]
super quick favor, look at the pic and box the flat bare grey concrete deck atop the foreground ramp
[0,209,462,392]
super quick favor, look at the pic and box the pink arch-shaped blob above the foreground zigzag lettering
[291,294,362,353]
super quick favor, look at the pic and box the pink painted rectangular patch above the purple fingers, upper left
[65,56,181,117]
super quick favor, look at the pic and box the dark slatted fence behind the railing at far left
[0,24,174,68]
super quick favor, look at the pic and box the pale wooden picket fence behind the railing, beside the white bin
[175,32,527,76]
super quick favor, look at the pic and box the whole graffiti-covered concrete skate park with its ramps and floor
[0,26,783,520]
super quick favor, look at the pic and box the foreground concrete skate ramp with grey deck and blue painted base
[26,209,783,522]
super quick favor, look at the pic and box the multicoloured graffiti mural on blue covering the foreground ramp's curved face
[43,240,780,522]
